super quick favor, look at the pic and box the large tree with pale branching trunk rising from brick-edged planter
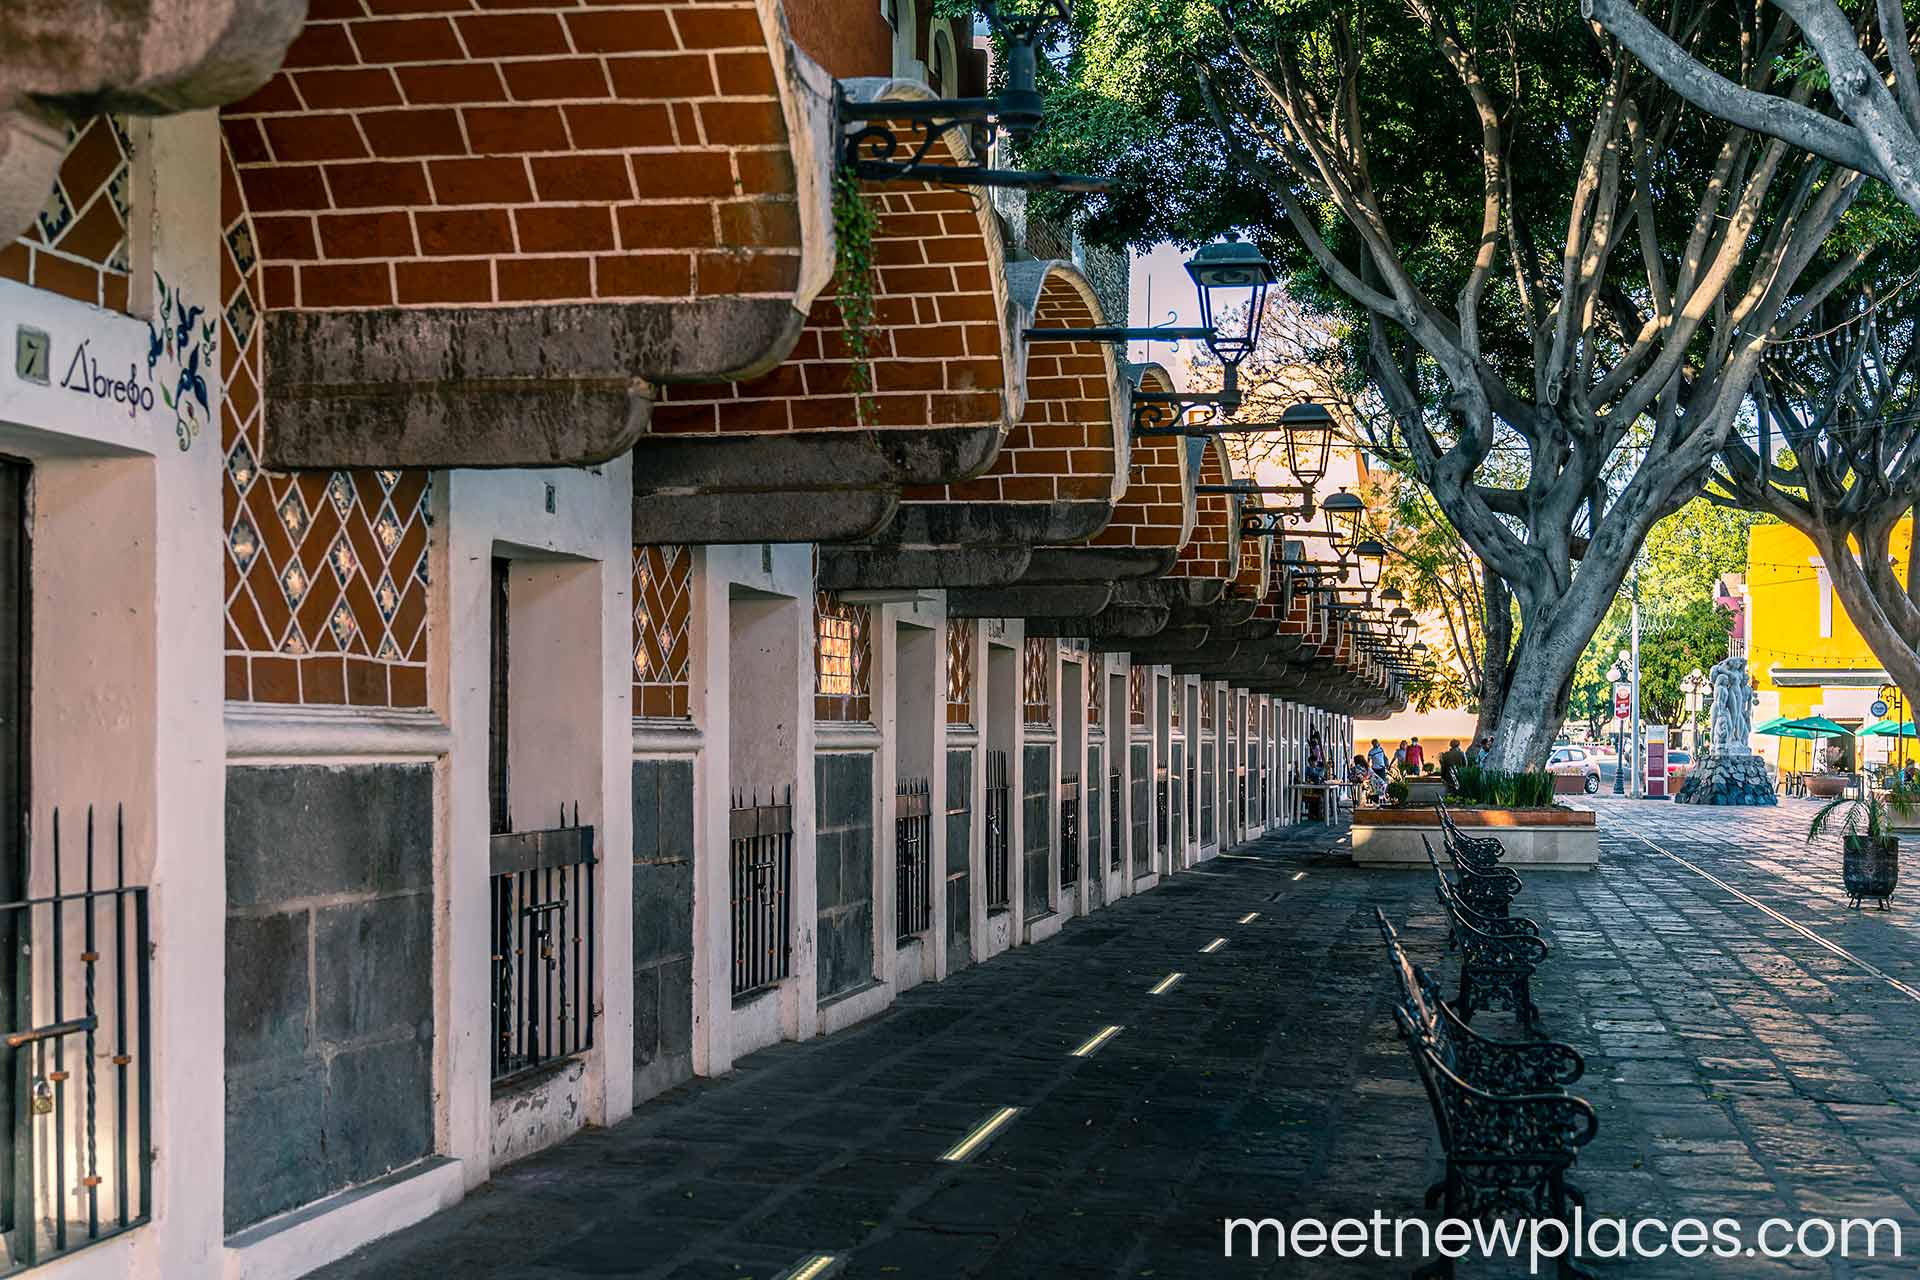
[1043,0,1878,768]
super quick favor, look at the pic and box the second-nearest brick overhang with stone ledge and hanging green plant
[634,79,1021,541]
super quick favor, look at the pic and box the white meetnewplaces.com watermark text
[1223,1209,1905,1272]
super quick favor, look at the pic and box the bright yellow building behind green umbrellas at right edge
[1745,520,1916,768]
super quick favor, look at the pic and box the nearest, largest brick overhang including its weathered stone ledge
[223,0,829,466]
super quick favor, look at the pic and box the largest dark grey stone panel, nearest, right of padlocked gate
[224,764,434,1234]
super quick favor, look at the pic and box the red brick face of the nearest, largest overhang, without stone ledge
[223,0,801,309]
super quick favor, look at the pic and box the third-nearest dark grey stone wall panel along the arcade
[814,750,874,998]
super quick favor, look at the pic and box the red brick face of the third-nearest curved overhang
[902,273,1119,503]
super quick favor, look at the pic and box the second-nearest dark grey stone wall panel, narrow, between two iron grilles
[634,760,693,1096]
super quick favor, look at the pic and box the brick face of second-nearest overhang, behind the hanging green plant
[651,144,1006,434]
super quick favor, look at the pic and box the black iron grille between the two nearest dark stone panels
[488,804,597,1082]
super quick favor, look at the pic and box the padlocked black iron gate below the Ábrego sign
[0,806,154,1272]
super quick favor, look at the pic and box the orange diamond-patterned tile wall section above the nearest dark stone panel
[219,134,430,706]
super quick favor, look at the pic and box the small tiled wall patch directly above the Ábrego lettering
[0,115,132,311]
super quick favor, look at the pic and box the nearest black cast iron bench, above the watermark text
[1375,908,1599,1278]
